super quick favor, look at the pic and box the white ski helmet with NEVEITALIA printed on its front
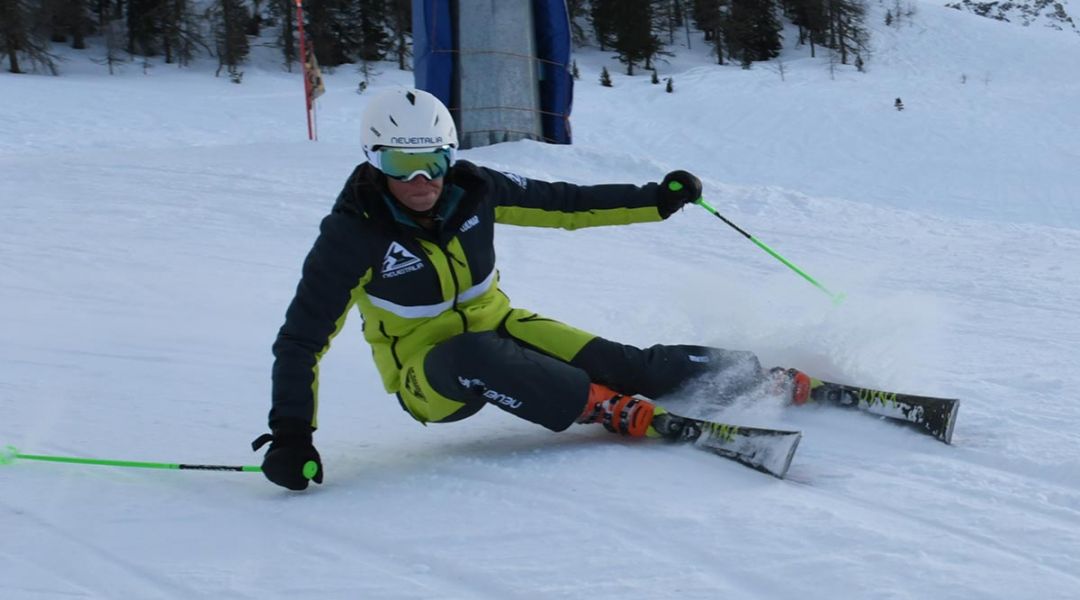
[360,87,458,158]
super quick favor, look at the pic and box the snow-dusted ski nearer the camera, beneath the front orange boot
[652,408,802,479]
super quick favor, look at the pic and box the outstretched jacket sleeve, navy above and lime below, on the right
[480,167,663,229]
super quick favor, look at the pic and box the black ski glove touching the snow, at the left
[252,419,323,491]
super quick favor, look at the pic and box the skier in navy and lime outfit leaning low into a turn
[252,88,809,490]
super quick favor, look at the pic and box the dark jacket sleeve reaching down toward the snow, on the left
[270,213,372,429]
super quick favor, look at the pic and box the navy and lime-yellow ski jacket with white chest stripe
[270,161,662,427]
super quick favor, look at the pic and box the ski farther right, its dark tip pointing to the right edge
[810,378,960,444]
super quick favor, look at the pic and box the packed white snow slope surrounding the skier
[0,2,1080,600]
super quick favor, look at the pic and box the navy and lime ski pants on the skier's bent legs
[397,310,760,432]
